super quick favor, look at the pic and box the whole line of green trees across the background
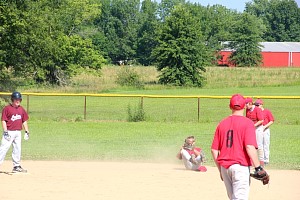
[0,0,300,87]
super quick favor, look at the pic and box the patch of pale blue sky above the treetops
[165,0,300,12]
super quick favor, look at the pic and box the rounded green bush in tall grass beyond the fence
[116,67,144,89]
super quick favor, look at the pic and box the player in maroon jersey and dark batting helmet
[0,92,29,173]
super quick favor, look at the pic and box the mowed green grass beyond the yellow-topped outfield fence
[22,86,300,125]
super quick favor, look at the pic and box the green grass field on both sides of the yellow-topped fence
[2,68,300,170]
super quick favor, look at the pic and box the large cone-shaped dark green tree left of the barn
[152,5,207,87]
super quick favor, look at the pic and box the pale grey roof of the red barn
[260,42,300,52]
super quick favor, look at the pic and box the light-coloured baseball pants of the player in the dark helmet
[0,131,22,167]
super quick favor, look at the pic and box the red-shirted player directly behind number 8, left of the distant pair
[246,98,264,166]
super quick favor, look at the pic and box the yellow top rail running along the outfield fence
[0,92,300,99]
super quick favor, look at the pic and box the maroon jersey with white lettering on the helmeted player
[1,105,29,131]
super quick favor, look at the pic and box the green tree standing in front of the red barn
[229,13,264,67]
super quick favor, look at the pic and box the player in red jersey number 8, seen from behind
[211,94,265,200]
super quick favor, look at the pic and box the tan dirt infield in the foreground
[0,161,300,200]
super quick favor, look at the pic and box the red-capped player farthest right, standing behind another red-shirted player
[254,99,274,164]
